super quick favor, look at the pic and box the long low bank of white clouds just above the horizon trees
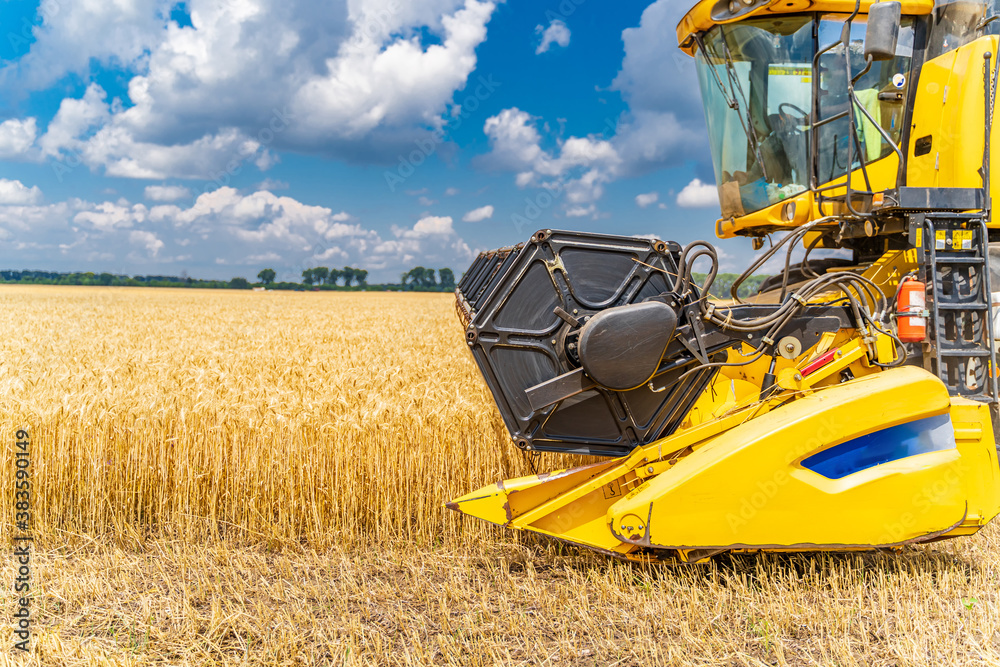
[0,187,473,280]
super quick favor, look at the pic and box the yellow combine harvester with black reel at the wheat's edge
[448,0,1000,562]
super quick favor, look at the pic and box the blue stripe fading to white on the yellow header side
[802,414,955,479]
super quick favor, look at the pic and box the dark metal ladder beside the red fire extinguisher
[918,213,998,404]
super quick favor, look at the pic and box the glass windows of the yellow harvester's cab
[697,14,913,217]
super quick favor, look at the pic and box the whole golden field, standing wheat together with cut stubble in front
[0,287,1000,666]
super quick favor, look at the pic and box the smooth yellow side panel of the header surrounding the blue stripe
[608,367,1000,548]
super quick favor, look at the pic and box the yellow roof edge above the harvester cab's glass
[677,0,934,53]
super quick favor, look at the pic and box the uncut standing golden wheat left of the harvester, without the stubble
[0,287,548,547]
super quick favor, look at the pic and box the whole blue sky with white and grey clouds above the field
[0,0,740,282]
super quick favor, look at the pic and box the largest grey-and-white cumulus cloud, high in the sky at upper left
[0,0,496,180]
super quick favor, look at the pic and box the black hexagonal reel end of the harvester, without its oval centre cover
[457,230,688,456]
